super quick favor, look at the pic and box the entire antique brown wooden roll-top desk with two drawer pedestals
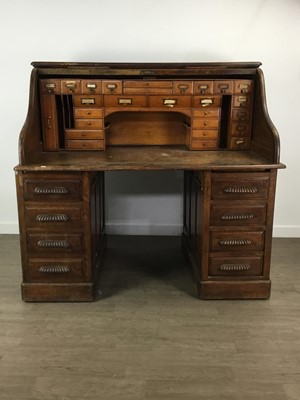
[15,62,285,301]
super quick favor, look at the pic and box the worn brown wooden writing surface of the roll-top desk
[16,146,284,171]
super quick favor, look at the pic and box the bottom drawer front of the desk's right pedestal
[208,256,263,279]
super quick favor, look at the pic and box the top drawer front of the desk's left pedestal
[24,175,82,202]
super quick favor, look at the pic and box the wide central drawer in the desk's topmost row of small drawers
[123,80,173,94]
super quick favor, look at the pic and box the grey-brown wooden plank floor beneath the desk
[0,235,300,400]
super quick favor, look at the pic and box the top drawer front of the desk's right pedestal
[212,172,269,200]
